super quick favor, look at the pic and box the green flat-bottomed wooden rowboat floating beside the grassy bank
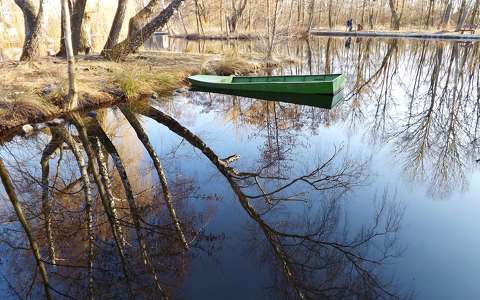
[188,74,345,95]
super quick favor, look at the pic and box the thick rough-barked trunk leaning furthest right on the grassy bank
[104,0,184,61]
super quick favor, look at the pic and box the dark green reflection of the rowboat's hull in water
[190,87,344,109]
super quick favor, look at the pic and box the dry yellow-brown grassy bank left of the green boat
[0,52,207,132]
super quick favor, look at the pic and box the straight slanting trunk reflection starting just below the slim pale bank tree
[72,114,132,297]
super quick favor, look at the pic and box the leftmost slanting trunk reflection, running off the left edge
[0,158,52,299]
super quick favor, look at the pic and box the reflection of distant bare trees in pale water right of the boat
[187,38,480,197]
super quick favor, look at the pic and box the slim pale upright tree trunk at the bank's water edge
[61,0,78,110]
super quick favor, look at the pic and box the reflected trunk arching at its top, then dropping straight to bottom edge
[52,127,95,299]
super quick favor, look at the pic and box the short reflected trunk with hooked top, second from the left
[40,132,63,264]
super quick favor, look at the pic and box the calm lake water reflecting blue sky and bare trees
[0,37,480,299]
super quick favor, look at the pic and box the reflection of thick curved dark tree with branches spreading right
[140,107,401,299]
